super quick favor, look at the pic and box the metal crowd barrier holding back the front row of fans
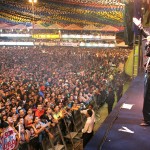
[18,98,101,150]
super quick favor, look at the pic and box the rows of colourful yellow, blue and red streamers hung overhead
[0,0,127,26]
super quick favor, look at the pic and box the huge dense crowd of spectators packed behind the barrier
[0,47,130,150]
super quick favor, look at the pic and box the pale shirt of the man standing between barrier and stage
[82,117,94,133]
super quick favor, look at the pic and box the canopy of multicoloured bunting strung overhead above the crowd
[0,0,129,30]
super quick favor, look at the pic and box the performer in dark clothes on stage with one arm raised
[133,18,150,126]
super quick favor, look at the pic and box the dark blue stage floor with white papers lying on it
[84,75,150,150]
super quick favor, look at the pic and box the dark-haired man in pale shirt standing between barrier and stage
[82,109,94,147]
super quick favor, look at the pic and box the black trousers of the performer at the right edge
[143,73,150,124]
